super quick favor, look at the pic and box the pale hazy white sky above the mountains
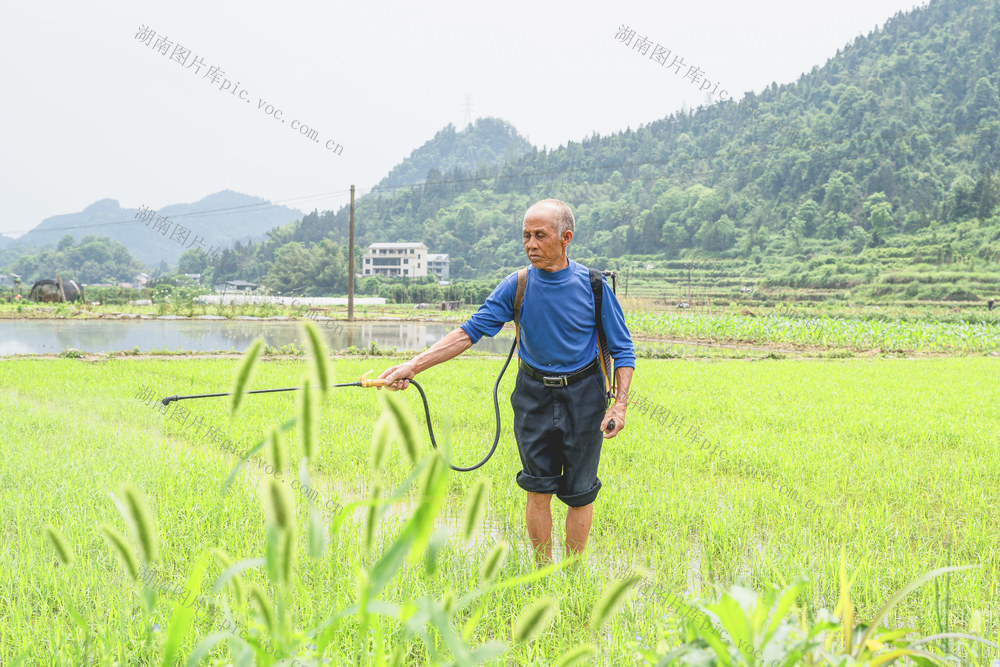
[0,0,925,236]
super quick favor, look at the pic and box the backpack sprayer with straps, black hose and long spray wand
[160,269,617,472]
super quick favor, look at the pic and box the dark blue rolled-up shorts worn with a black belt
[510,369,608,507]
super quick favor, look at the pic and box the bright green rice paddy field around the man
[0,350,1000,665]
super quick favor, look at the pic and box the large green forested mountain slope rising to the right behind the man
[288,0,1000,298]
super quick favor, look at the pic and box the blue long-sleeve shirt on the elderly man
[462,260,635,374]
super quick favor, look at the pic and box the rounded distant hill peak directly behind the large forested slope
[374,118,532,190]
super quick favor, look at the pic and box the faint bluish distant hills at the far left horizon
[7,190,302,267]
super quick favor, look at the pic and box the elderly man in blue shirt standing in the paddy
[379,199,635,565]
